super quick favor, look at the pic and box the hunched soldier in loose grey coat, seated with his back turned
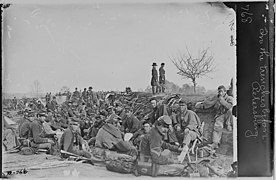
[95,116,137,156]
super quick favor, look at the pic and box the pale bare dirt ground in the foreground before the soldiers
[2,153,232,179]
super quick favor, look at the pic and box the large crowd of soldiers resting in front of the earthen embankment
[3,82,233,177]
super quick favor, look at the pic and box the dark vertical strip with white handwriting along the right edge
[236,2,274,177]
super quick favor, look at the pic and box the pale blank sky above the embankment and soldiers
[2,3,236,93]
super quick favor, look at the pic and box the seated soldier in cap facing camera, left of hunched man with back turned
[60,122,91,158]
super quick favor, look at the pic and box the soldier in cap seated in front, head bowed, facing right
[140,115,182,165]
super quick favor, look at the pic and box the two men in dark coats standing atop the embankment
[151,62,165,94]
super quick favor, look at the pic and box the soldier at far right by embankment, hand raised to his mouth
[196,85,233,149]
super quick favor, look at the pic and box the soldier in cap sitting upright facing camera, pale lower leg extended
[173,99,201,163]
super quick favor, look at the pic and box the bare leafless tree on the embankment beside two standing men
[170,47,215,93]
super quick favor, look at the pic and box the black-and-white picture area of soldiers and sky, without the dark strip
[2,0,268,179]
